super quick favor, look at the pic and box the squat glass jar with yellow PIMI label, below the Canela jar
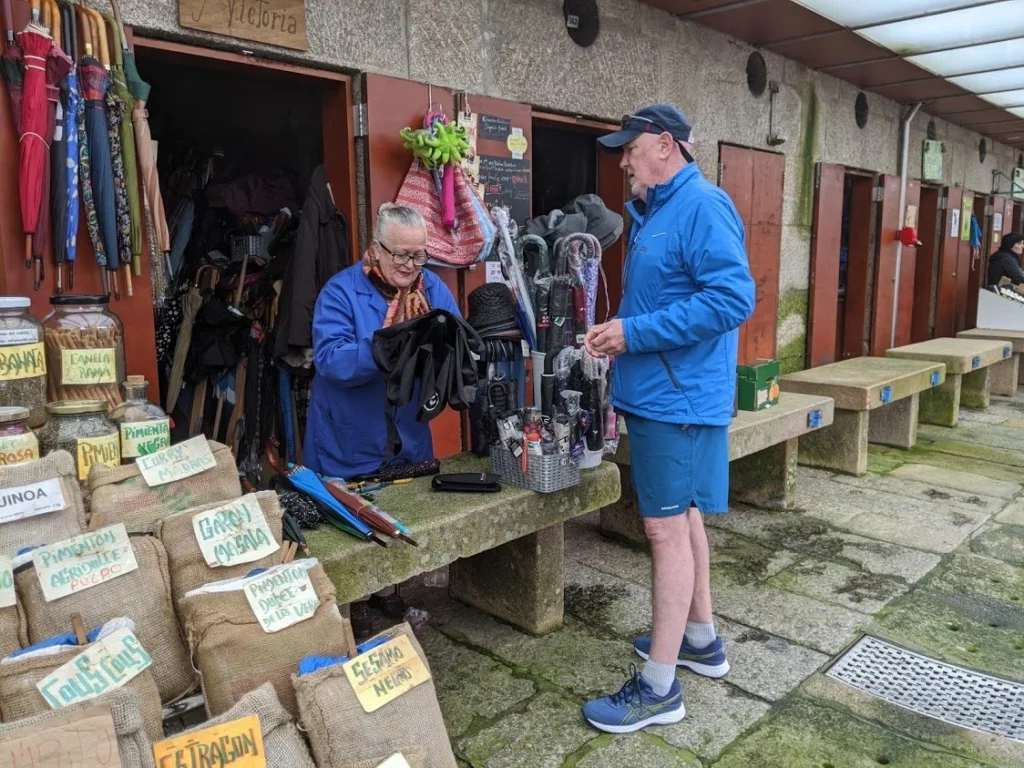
[39,400,121,487]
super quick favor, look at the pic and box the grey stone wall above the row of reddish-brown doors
[114,0,1017,366]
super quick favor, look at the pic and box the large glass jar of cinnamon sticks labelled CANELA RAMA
[43,296,125,410]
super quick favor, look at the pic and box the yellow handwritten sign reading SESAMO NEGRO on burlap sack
[342,635,430,713]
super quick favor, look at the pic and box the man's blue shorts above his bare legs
[626,415,729,517]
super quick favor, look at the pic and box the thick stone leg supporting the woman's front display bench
[449,523,565,635]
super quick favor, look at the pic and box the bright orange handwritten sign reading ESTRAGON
[153,715,266,768]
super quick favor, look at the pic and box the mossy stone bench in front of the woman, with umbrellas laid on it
[306,454,620,635]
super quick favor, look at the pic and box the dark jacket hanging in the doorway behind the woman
[273,165,352,357]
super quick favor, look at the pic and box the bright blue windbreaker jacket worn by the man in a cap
[611,163,754,426]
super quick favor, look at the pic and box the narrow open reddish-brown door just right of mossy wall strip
[807,163,846,368]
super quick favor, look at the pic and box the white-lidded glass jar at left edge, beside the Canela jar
[0,296,46,427]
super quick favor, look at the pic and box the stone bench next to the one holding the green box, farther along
[780,357,946,475]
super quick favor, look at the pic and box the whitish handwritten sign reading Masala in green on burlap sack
[193,494,281,567]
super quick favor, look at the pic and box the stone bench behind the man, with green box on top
[601,392,833,543]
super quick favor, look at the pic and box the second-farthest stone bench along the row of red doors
[886,338,1019,427]
